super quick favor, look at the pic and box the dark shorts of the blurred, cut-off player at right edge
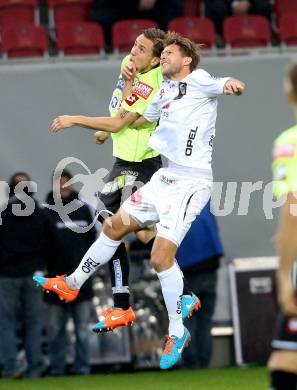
[271,313,297,351]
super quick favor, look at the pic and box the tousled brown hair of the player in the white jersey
[164,31,200,72]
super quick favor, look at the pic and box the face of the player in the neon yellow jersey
[131,34,156,73]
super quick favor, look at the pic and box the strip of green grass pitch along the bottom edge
[0,367,268,390]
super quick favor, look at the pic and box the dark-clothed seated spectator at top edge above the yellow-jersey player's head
[91,0,183,46]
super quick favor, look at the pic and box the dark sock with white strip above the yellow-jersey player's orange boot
[109,243,130,310]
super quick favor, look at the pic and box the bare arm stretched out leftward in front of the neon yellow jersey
[51,108,139,133]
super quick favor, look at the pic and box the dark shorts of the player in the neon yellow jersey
[97,156,162,213]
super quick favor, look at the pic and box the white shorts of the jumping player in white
[122,168,212,246]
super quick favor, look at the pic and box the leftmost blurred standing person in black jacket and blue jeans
[0,172,55,378]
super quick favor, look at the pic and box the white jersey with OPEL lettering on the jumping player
[143,69,229,170]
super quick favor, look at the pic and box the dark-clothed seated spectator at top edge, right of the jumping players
[204,0,272,36]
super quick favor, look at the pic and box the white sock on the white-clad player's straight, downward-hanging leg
[157,264,184,337]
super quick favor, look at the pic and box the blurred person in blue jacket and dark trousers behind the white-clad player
[176,202,223,369]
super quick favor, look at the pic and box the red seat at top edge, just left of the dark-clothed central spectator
[48,0,92,28]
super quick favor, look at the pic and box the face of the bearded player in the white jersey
[160,45,187,78]
